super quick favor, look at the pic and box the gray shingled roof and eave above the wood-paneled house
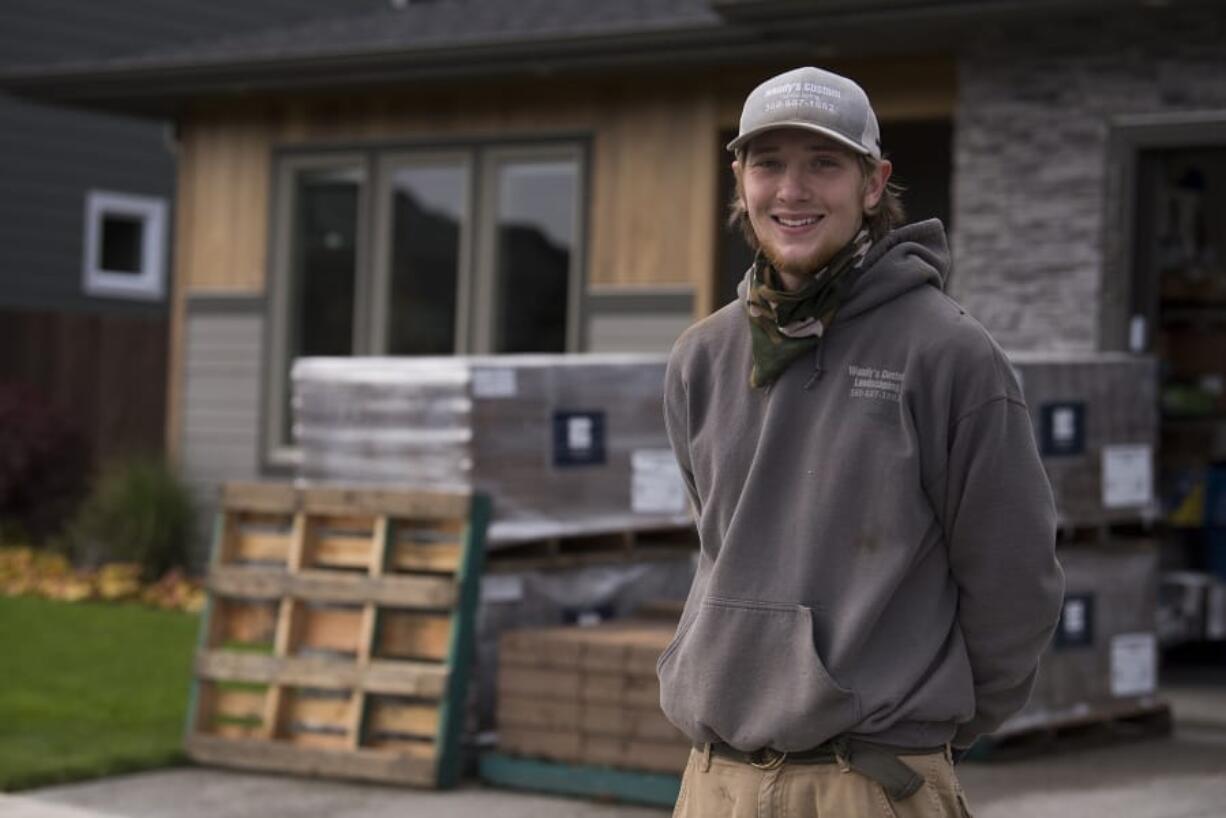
[0,0,1186,115]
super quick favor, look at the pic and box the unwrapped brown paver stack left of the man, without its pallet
[498,621,690,774]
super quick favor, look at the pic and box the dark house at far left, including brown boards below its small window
[0,0,384,465]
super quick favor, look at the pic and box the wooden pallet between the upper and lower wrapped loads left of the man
[485,525,699,574]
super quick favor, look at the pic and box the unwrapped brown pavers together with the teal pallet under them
[481,621,690,805]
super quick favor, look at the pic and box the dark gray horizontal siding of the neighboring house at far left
[0,0,386,315]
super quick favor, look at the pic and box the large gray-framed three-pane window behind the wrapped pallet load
[265,142,585,462]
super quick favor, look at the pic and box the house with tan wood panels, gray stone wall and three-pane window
[0,0,1226,566]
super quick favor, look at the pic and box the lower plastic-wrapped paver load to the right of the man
[1000,541,1159,733]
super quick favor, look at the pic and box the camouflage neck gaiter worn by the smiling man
[744,229,873,389]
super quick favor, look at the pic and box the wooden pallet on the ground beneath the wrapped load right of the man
[965,700,1172,762]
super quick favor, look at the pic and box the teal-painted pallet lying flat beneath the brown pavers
[478,753,682,807]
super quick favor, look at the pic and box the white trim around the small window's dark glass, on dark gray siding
[81,190,168,300]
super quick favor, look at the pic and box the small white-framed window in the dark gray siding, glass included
[83,190,167,300]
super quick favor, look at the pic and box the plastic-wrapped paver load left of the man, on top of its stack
[292,354,689,547]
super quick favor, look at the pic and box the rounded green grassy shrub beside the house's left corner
[69,457,195,579]
